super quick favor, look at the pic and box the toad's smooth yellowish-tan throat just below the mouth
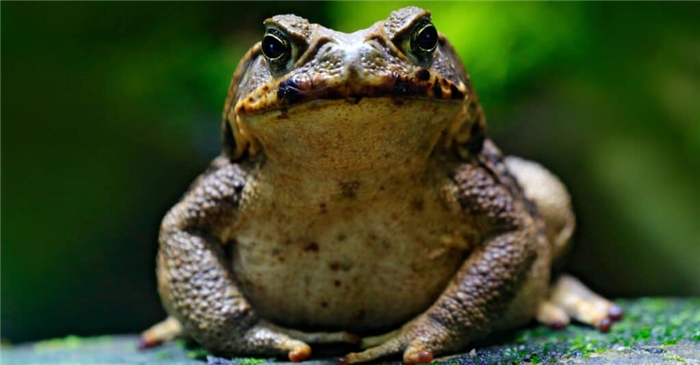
[237,97,464,176]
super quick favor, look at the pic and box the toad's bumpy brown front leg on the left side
[146,157,311,361]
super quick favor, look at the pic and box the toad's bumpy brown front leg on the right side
[341,161,546,363]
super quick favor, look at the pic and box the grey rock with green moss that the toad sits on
[0,298,700,365]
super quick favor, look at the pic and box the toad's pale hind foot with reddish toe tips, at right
[537,275,623,332]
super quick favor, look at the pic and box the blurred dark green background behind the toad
[0,0,700,342]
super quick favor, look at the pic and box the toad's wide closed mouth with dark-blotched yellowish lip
[235,69,469,116]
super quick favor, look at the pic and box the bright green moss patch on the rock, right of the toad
[456,298,700,363]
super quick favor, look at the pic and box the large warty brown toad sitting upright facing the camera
[143,7,621,363]
